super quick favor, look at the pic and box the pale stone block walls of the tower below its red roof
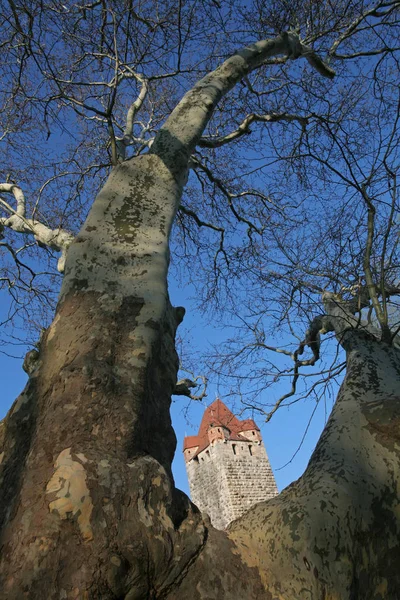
[186,440,278,529]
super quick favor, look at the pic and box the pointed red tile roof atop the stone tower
[183,398,260,458]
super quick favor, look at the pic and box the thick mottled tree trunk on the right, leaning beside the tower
[229,330,400,600]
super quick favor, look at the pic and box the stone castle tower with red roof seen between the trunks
[183,399,278,529]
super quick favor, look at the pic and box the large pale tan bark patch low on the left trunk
[46,448,93,541]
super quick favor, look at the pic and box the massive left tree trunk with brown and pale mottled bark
[0,155,268,600]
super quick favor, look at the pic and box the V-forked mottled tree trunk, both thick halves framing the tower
[0,170,400,600]
